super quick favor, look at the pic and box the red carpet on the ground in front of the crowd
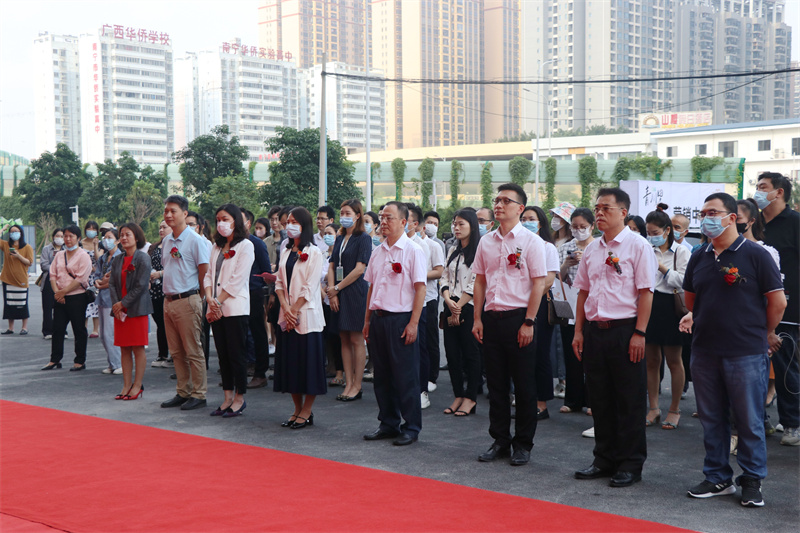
[0,401,685,533]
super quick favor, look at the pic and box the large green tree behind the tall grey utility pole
[261,127,362,211]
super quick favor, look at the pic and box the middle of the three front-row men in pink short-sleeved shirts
[472,183,547,466]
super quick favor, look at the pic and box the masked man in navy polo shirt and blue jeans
[683,193,786,507]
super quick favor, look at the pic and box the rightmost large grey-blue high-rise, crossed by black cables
[673,0,793,124]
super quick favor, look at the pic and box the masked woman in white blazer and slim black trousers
[203,204,255,418]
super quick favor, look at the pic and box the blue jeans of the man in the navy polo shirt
[691,350,769,483]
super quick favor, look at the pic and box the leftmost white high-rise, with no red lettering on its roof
[33,33,81,154]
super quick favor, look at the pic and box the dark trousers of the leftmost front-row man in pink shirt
[369,312,422,437]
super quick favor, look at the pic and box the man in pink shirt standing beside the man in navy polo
[572,188,658,487]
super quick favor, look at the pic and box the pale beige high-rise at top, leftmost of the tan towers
[258,0,371,68]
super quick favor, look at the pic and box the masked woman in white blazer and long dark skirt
[275,207,327,429]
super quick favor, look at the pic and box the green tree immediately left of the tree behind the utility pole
[172,125,250,217]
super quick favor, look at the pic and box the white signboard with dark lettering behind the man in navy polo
[620,180,725,229]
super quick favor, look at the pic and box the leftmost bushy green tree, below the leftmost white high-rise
[15,143,88,223]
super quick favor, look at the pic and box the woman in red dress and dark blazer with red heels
[109,223,153,400]
